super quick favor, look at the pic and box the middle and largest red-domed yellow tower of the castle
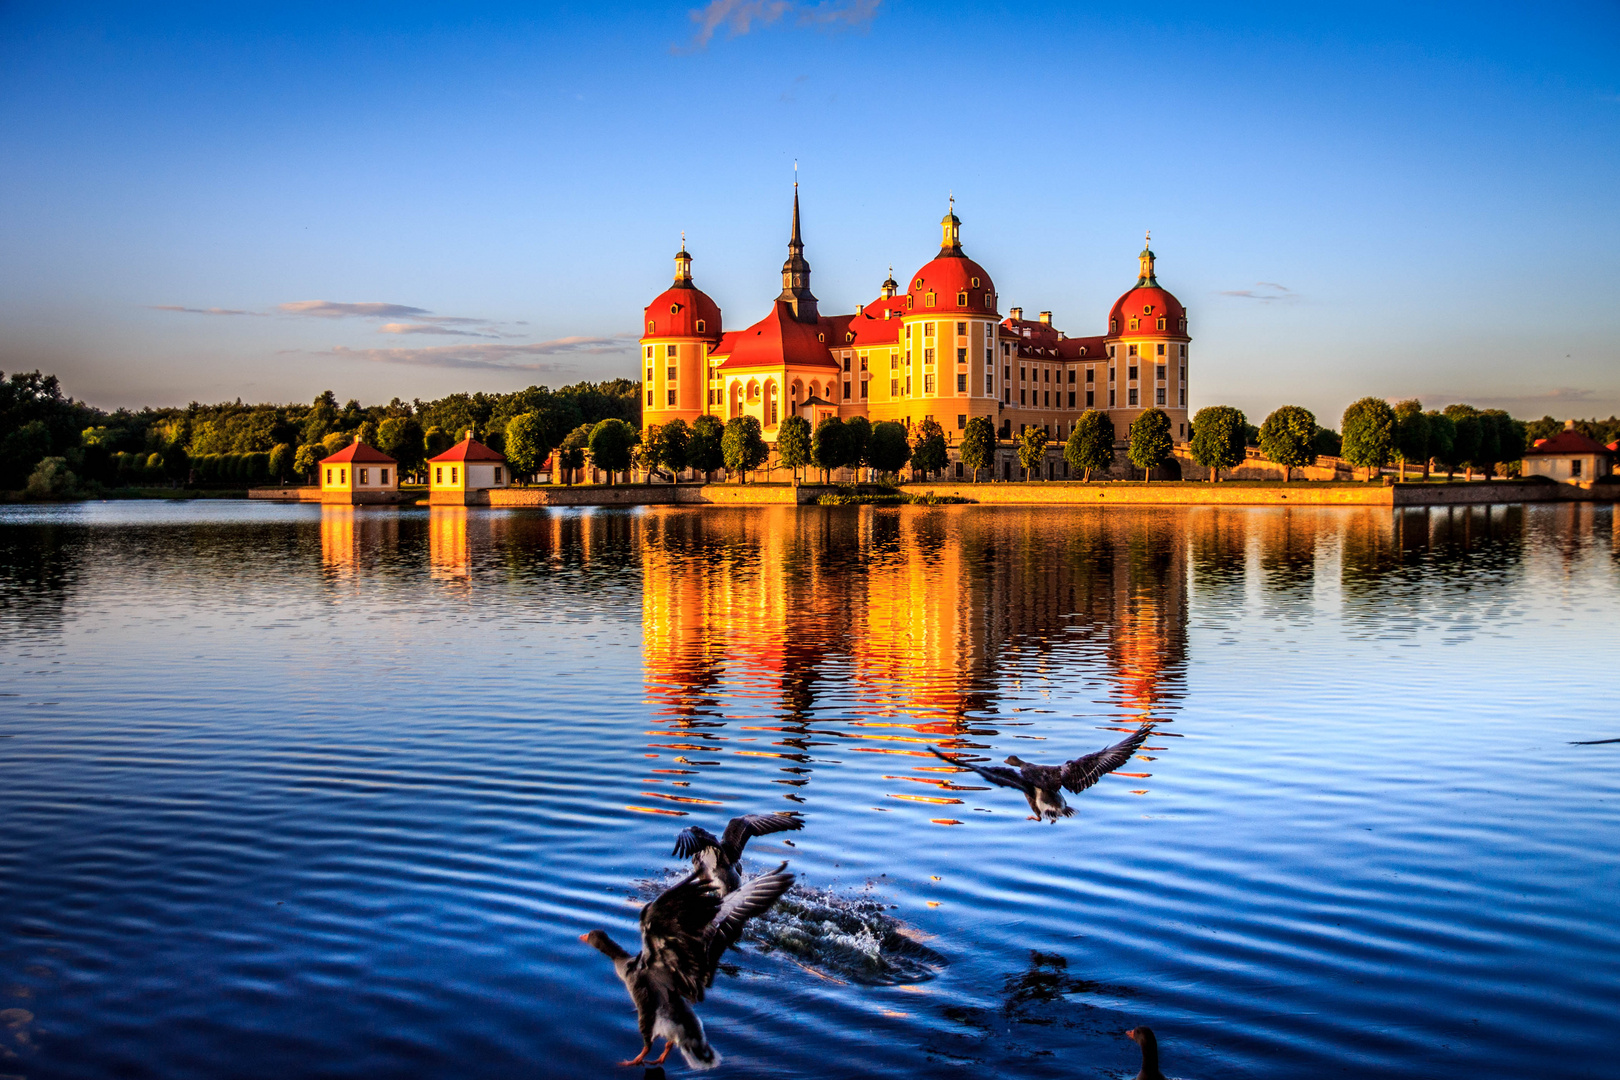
[870,199,1001,436]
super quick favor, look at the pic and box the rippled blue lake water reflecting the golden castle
[0,504,1620,1080]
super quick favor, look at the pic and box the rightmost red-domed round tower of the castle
[1103,233,1192,442]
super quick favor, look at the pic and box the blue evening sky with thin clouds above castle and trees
[0,0,1620,426]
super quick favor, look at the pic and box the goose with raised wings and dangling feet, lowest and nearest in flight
[580,863,794,1069]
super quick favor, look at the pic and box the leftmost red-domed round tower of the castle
[642,244,719,427]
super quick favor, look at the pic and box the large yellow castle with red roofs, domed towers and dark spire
[642,183,1192,458]
